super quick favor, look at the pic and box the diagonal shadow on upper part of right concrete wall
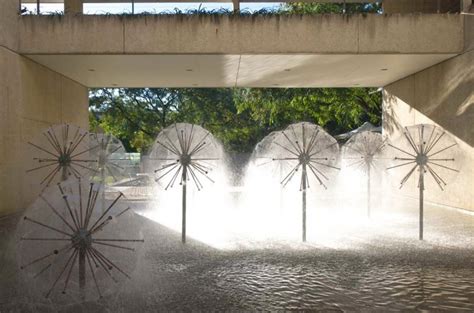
[383,51,474,147]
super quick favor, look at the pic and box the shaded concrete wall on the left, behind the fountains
[0,47,88,216]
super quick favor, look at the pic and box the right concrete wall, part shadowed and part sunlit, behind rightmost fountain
[383,50,474,211]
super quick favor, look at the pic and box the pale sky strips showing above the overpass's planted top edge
[23,2,280,14]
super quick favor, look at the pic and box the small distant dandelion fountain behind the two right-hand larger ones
[342,131,386,218]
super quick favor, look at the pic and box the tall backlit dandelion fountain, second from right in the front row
[259,123,340,242]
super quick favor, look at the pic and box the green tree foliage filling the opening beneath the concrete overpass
[90,88,381,152]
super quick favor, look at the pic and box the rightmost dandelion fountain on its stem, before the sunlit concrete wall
[387,124,459,240]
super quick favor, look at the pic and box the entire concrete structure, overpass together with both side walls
[0,0,474,215]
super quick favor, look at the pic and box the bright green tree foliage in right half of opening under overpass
[236,88,382,135]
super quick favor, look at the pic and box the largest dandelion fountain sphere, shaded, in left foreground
[17,179,144,303]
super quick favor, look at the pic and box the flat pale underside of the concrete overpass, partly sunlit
[27,54,454,88]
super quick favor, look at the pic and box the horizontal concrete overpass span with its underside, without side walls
[19,14,465,87]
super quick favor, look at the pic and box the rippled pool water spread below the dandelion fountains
[0,201,474,312]
